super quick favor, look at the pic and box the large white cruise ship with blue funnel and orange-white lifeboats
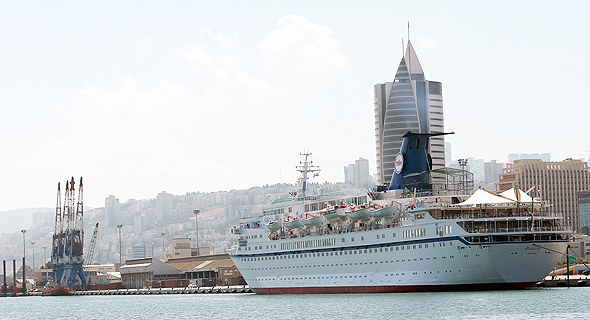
[230,132,569,294]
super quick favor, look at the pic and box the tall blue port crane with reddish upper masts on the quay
[51,177,86,289]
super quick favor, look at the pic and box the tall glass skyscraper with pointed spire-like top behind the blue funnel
[374,41,445,185]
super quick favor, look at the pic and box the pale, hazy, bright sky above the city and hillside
[0,0,590,211]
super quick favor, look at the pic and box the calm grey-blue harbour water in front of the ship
[0,288,590,320]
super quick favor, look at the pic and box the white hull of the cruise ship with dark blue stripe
[231,211,567,294]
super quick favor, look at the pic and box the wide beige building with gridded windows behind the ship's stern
[496,159,590,232]
